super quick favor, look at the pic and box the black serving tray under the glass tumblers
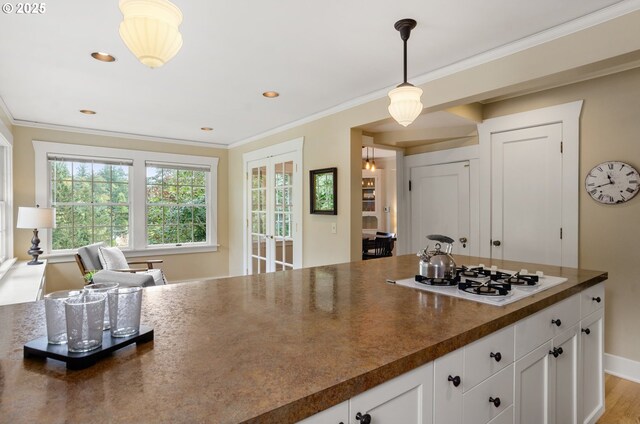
[24,325,153,370]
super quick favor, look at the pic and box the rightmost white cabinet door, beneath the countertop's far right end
[579,308,604,424]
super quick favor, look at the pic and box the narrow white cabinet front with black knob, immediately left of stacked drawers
[433,348,465,424]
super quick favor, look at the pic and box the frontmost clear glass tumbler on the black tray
[64,292,107,352]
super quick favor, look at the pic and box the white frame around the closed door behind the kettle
[397,145,480,256]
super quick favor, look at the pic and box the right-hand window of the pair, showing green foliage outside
[147,162,209,246]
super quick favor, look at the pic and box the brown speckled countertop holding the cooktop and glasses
[0,255,607,423]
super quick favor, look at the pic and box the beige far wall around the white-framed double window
[13,126,229,292]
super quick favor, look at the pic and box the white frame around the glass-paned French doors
[242,137,304,275]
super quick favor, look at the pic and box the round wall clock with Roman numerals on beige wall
[584,161,640,205]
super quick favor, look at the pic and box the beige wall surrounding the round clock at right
[484,69,640,361]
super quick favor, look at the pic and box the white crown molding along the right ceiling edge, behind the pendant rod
[229,0,640,149]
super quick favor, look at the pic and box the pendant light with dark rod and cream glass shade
[389,19,423,127]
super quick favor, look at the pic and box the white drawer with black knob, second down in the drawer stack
[462,364,513,424]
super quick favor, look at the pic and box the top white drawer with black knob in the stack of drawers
[463,326,514,391]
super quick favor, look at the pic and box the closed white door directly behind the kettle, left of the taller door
[410,161,470,255]
